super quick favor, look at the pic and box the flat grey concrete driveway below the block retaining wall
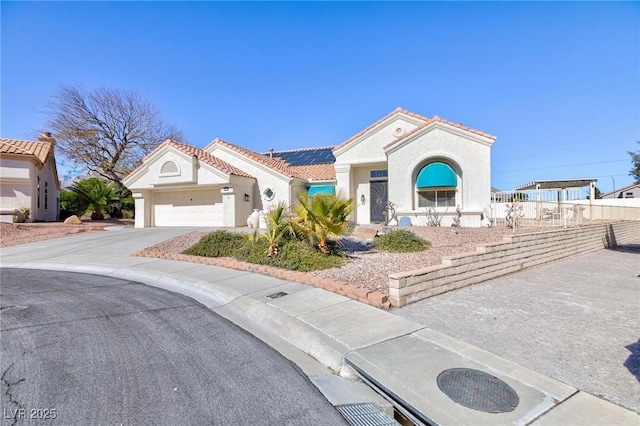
[393,246,640,412]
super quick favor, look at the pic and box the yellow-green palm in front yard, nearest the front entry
[293,192,353,254]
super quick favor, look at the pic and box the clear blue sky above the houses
[0,1,640,192]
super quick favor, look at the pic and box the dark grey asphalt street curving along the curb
[0,269,345,425]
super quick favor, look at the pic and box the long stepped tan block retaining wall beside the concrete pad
[389,221,640,307]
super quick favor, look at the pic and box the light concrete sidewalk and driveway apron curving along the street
[0,228,640,426]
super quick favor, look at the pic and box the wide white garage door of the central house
[153,189,222,226]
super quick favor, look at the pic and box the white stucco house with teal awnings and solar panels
[124,108,496,227]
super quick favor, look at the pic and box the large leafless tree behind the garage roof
[47,86,182,188]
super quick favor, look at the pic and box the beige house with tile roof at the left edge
[0,133,60,222]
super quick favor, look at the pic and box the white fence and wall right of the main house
[487,189,640,228]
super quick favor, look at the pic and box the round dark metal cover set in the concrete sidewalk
[438,368,520,413]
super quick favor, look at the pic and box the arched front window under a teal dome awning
[416,162,458,208]
